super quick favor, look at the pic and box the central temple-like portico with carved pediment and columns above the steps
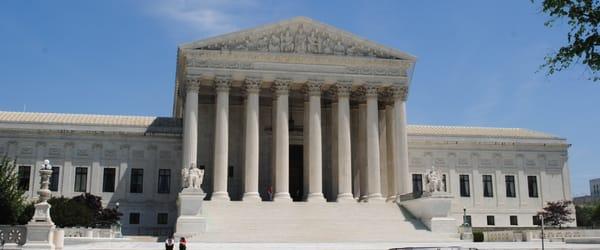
[174,18,415,202]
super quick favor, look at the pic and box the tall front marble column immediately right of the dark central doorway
[304,80,325,202]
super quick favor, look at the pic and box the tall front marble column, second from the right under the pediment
[365,84,385,202]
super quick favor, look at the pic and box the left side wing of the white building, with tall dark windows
[0,112,181,235]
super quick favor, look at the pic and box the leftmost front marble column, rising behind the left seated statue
[182,80,199,173]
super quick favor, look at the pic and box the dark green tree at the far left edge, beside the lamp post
[0,156,25,225]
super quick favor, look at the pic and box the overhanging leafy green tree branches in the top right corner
[532,0,600,81]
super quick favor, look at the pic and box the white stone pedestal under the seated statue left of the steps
[175,188,206,237]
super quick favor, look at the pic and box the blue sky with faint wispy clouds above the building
[0,0,600,195]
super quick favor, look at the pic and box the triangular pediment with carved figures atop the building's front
[180,17,416,61]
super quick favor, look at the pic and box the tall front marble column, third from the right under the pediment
[334,83,354,202]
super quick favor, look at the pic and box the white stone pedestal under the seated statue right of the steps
[401,192,458,237]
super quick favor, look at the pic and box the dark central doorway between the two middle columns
[290,145,304,201]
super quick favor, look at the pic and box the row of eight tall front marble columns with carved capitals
[183,77,410,202]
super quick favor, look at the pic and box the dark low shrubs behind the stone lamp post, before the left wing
[20,193,121,227]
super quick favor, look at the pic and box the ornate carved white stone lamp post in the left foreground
[23,160,55,249]
